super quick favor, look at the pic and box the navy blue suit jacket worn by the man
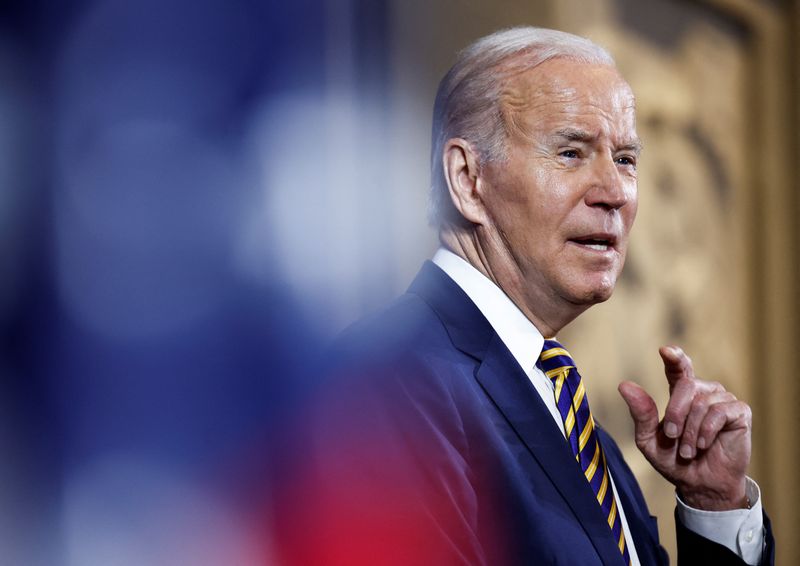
[282,262,774,566]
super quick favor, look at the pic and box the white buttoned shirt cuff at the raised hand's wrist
[675,478,764,566]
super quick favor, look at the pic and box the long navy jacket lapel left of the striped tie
[409,262,622,565]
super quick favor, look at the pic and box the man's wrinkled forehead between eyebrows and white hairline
[501,58,636,138]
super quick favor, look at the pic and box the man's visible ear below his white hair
[442,138,486,224]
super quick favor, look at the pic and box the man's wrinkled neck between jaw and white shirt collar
[439,226,588,338]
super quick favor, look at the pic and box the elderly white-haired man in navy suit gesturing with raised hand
[276,28,774,565]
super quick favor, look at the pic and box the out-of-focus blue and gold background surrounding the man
[0,0,800,566]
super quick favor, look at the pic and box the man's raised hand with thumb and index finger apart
[619,346,752,511]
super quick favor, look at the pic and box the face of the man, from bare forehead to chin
[482,59,639,324]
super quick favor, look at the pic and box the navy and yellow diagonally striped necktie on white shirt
[538,340,631,564]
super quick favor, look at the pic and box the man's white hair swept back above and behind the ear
[429,26,615,229]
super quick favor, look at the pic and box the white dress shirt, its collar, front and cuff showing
[433,248,764,566]
